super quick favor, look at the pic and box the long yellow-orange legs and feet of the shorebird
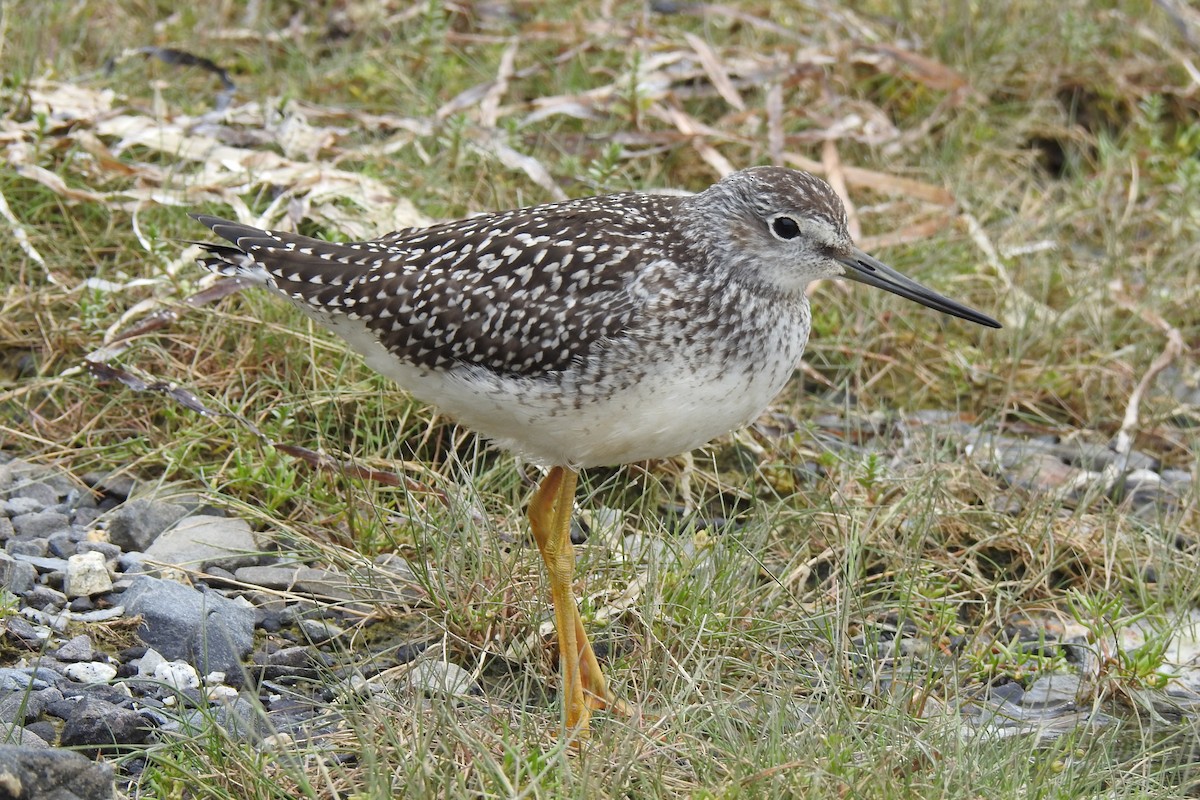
[529,467,625,735]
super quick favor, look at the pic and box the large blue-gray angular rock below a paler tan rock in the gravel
[122,575,254,678]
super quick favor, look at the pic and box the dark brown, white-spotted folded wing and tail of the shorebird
[196,194,678,375]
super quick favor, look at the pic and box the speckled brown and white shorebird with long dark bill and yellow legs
[191,166,1001,739]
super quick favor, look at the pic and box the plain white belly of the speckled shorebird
[325,307,808,468]
